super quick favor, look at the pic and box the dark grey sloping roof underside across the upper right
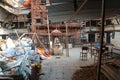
[47,0,120,22]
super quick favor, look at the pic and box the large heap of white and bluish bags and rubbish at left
[0,34,49,80]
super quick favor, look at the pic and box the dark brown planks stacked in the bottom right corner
[102,58,120,80]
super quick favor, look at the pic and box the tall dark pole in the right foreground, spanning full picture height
[97,0,105,80]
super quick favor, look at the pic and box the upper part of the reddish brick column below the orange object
[31,0,47,32]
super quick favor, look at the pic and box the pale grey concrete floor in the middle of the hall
[40,48,94,80]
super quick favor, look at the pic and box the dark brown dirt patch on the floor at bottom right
[72,66,108,80]
